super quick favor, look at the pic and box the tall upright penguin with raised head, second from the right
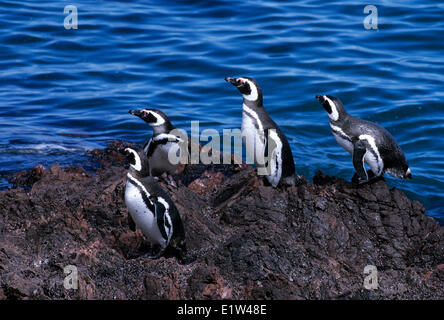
[225,77,296,187]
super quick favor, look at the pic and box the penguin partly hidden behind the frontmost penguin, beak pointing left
[129,109,186,176]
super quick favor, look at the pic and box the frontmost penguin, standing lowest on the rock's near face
[125,148,186,258]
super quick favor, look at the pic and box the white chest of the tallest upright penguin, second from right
[241,106,265,165]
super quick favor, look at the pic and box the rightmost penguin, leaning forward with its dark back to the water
[316,95,412,184]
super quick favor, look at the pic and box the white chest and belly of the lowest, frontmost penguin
[125,181,166,247]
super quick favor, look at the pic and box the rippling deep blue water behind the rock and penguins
[0,0,444,224]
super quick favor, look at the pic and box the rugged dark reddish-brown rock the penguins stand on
[0,142,444,299]
